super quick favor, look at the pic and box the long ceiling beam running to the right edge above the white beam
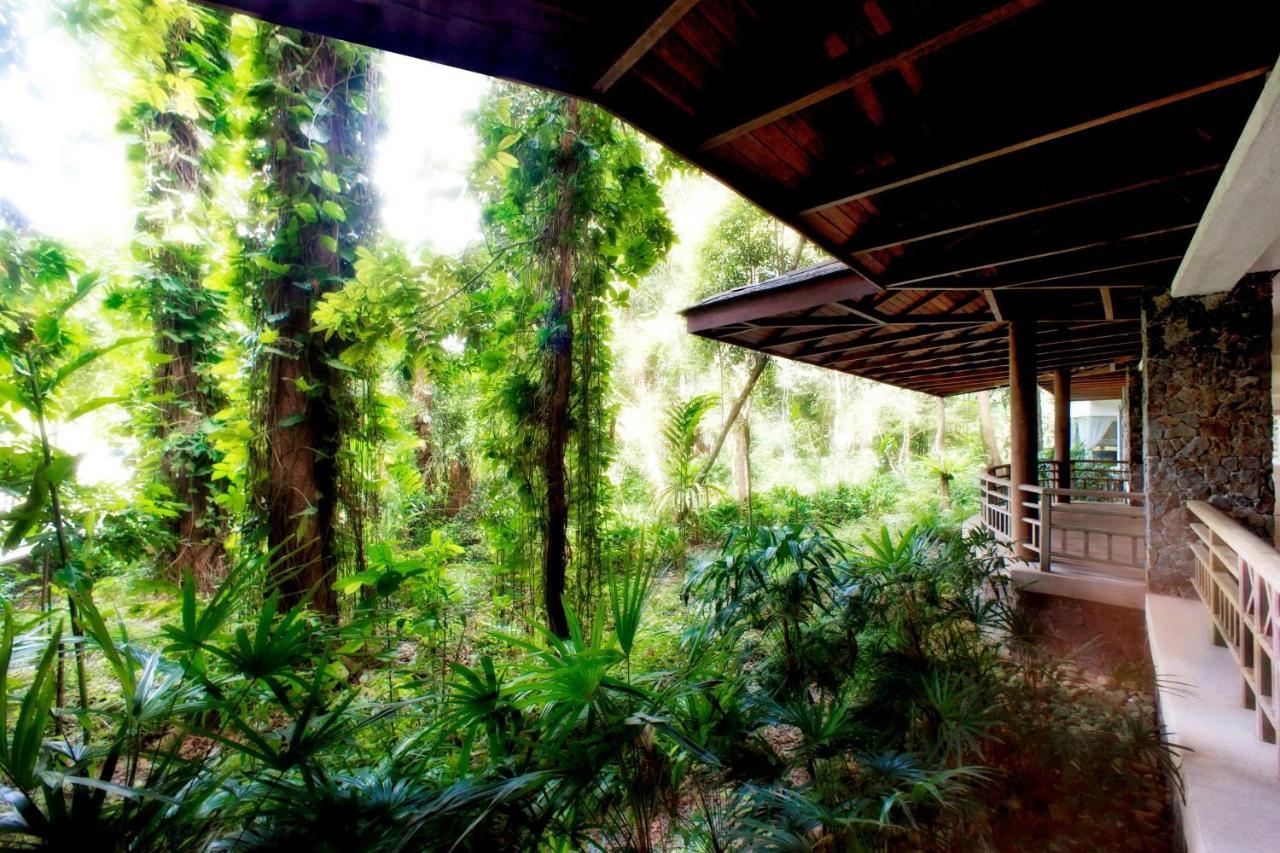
[796,65,1270,216]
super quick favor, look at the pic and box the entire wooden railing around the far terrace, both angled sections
[978,464,1147,579]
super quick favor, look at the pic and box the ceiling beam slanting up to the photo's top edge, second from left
[699,0,1042,151]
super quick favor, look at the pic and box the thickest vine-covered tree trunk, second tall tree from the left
[243,27,376,613]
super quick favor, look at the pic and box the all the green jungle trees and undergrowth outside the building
[0,8,1171,852]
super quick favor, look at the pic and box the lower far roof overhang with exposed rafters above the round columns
[684,261,1142,398]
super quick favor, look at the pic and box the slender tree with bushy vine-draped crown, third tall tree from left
[476,87,673,635]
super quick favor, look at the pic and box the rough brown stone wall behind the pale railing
[1142,275,1275,594]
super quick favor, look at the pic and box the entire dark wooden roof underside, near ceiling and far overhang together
[202,0,1280,393]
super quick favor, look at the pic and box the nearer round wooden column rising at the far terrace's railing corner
[1009,316,1039,560]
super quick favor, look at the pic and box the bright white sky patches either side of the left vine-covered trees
[0,0,489,254]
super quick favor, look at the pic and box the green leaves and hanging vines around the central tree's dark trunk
[471,86,673,617]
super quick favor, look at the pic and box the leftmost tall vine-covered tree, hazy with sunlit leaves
[90,0,232,588]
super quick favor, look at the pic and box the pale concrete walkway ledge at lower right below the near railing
[1147,594,1280,853]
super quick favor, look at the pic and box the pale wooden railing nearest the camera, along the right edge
[1187,501,1280,758]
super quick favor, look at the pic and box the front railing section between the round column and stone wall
[1021,485,1147,580]
